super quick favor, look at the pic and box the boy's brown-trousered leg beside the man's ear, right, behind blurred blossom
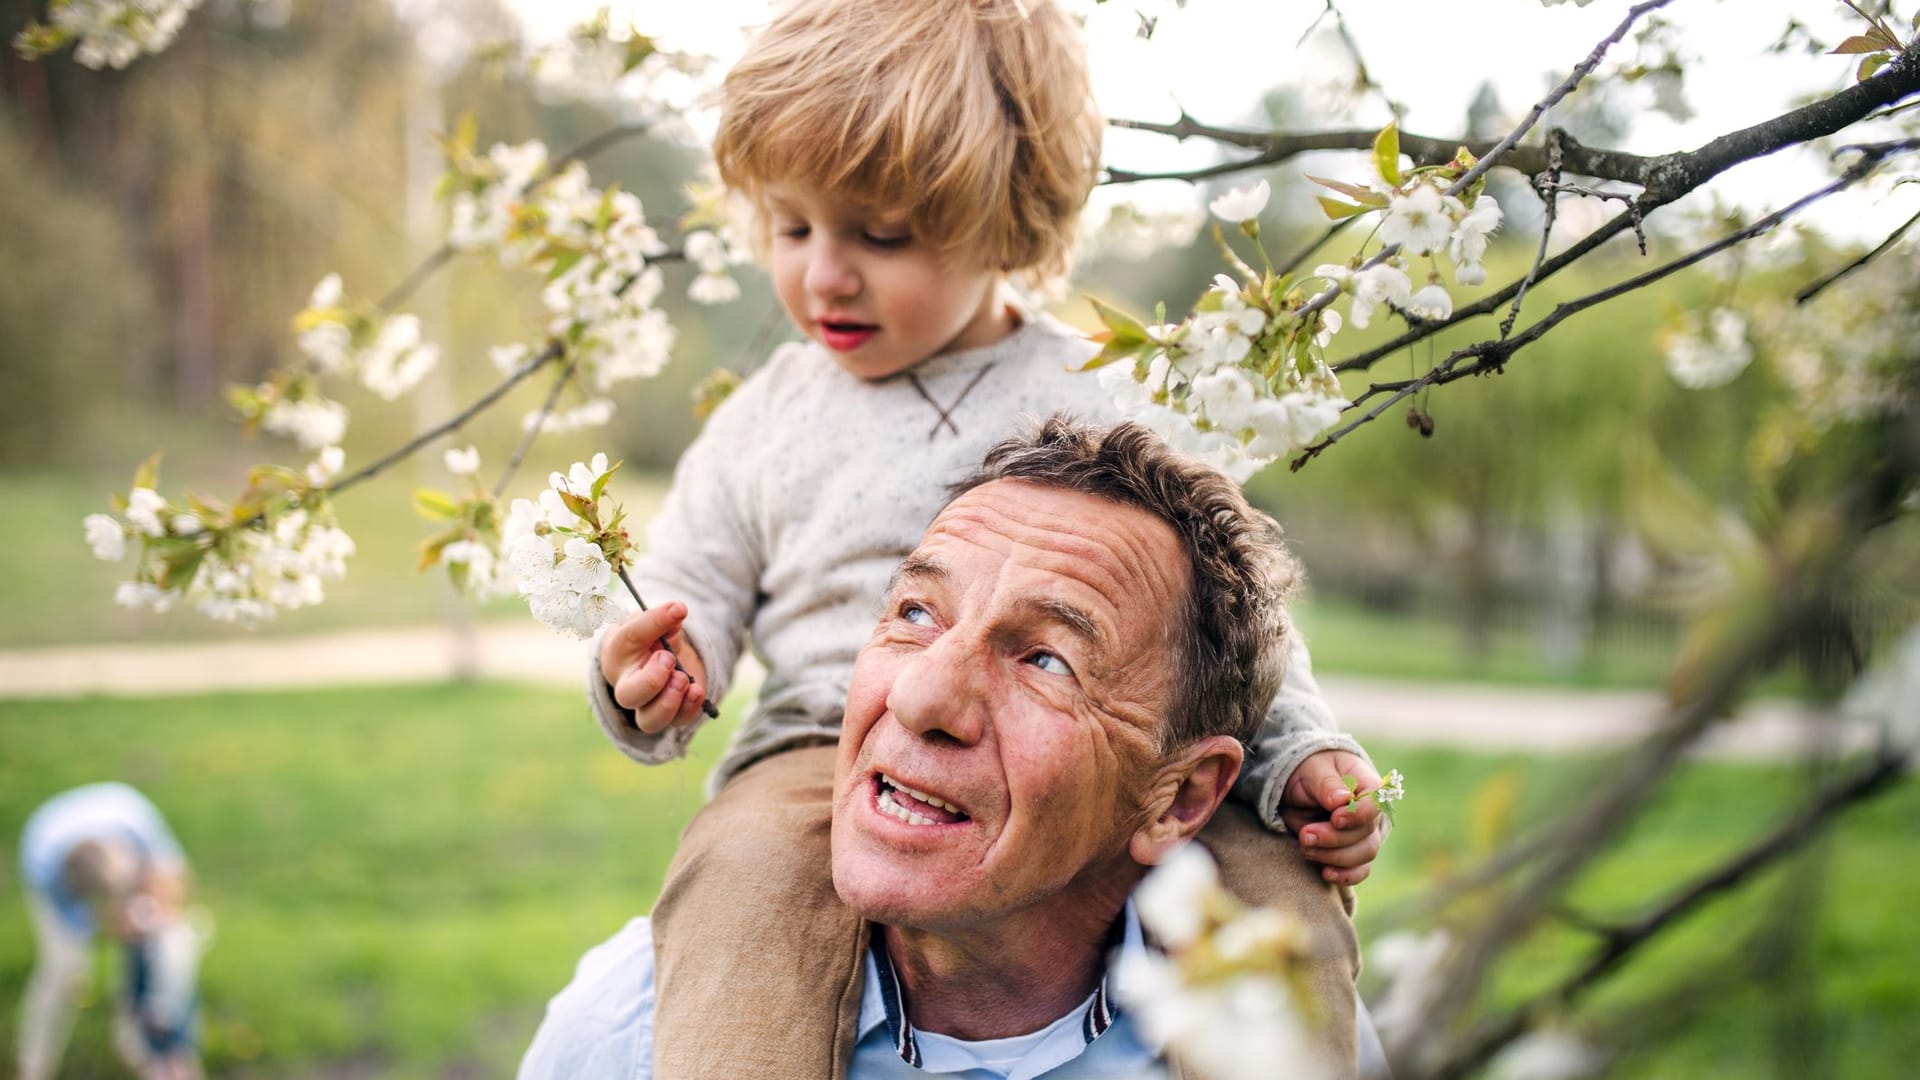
[1200,801,1359,1076]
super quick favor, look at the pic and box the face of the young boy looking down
[766,184,1014,379]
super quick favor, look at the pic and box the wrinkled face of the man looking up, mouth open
[833,480,1188,930]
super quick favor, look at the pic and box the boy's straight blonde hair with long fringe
[714,0,1102,282]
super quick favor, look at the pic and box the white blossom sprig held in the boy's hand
[501,454,628,638]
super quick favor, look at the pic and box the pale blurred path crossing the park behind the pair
[0,621,1872,759]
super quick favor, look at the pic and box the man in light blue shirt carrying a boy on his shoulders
[520,419,1357,1080]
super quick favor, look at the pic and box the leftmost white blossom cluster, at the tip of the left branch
[84,448,353,625]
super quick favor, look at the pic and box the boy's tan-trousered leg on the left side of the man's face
[653,746,864,1080]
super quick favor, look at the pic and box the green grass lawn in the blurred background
[0,684,1920,1078]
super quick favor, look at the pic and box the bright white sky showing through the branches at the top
[509,0,1920,242]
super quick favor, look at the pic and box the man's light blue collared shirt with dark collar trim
[518,903,1165,1080]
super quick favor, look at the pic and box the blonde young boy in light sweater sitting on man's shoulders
[589,0,1379,1080]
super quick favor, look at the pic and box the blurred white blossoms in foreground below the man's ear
[1114,844,1332,1080]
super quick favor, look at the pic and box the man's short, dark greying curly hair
[952,413,1298,749]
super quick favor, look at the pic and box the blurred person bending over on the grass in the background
[17,784,202,1080]
